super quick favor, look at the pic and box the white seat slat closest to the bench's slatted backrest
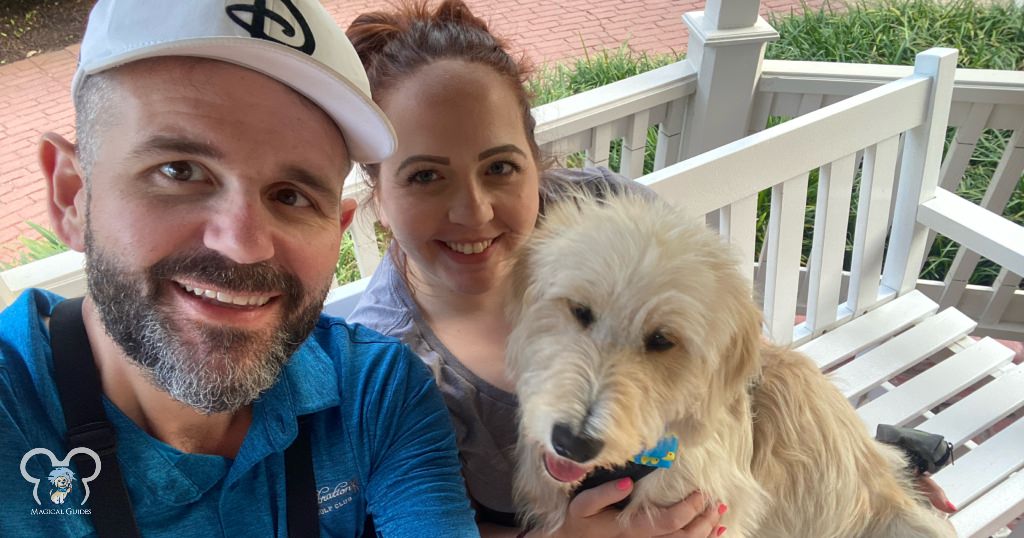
[797,290,938,370]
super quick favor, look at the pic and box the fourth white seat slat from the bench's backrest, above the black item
[916,365,1024,452]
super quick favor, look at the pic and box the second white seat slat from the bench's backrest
[831,308,977,398]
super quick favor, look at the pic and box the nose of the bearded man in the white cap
[203,196,273,263]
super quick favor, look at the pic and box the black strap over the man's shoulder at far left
[50,298,139,538]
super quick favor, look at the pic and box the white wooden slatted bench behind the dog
[326,49,1024,537]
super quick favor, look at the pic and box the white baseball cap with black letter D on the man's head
[72,0,395,163]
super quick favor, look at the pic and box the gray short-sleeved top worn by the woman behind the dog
[347,168,652,520]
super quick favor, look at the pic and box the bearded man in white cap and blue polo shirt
[0,0,476,537]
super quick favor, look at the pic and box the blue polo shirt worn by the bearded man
[0,290,478,538]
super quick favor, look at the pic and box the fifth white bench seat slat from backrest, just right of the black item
[933,420,1024,506]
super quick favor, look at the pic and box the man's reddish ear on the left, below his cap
[39,132,86,252]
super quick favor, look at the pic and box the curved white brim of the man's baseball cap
[72,37,396,163]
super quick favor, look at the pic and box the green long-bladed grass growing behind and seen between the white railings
[4,0,1024,284]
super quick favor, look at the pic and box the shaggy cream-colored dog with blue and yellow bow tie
[508,195,955,538]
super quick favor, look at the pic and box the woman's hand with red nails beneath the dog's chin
[526,479,726,538]
